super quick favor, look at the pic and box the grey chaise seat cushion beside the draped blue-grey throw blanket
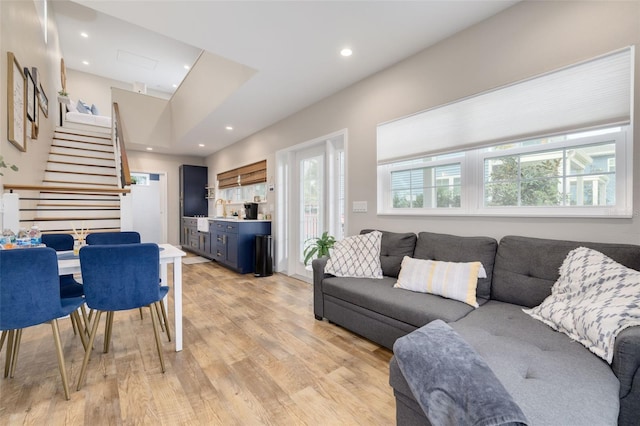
[450,301,620,425]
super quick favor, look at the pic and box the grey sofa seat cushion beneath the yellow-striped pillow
[322,277,473,327]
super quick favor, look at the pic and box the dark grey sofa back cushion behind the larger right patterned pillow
[491,235,640,308]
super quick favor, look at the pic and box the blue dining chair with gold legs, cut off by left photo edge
[0,247,86,399]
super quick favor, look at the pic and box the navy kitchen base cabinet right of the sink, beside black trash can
[209,220,271,274]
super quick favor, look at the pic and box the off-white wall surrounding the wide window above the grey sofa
[207,1,640,244]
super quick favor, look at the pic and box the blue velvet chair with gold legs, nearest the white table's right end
[77,243,169,390]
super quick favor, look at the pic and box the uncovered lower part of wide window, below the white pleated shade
[378,126,632,217]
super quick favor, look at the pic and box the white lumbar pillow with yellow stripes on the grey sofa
[394,256,487,308]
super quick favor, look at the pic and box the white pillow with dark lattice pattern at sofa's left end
[324,231,382,278]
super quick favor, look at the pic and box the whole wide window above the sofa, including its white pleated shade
[376,46,635,217]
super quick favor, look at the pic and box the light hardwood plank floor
[0,263,395,425]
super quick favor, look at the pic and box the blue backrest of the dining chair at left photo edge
[0,247,67,330]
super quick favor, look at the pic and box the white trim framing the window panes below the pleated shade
[377,125,633,218]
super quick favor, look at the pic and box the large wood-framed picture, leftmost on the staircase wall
[7,52,27,152]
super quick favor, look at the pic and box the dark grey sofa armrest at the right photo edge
[611,326,640,424]
